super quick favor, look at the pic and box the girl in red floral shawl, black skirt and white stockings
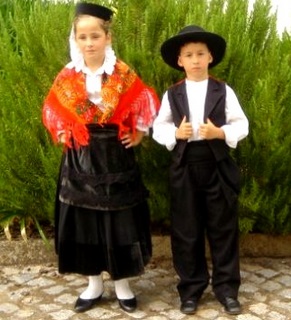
[43,3,159,312]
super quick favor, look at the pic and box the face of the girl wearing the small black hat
[75,15,111,68]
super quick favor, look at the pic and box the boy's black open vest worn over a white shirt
[168,78,229,164]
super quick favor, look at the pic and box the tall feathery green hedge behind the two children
[0,0,291,234]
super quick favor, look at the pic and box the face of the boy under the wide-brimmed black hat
[178,42,213,81]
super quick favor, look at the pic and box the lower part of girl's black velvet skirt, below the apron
[55,202,152,280]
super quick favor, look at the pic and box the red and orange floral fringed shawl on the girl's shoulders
[43,60,160,147]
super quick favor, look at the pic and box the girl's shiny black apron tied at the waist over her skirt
[59,125,151,210]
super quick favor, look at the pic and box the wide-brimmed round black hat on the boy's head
[161,25,226,71]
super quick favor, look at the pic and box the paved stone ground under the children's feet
[0,236,291,320]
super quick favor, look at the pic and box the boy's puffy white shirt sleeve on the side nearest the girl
[153,92,177,151]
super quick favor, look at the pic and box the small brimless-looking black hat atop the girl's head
[75,2,113,21]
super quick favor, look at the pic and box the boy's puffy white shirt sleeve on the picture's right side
[221,85,249,148]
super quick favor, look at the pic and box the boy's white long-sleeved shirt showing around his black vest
[153,79,249,151]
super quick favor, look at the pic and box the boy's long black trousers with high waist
[170,142,240,302]
